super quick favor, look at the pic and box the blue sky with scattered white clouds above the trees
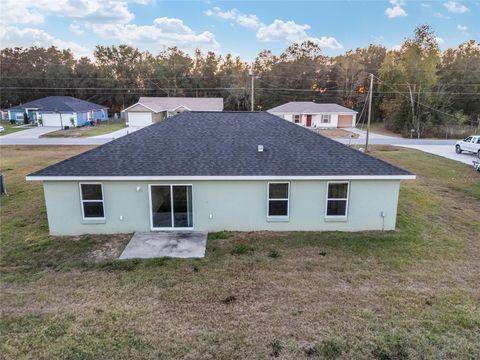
[0,0,480,61]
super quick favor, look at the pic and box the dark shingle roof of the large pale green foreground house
[31,112,410,176]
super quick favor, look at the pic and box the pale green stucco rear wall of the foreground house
[44,180,400,235]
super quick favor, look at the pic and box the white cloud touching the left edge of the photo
[0,26,92,56]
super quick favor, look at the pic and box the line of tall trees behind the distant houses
[0,25,480,137]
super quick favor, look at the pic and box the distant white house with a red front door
[267,101,357,128]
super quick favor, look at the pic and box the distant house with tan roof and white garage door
[123,96,223,127]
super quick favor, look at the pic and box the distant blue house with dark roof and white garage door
[8,96,108,126]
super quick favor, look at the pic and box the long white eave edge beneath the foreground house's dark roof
[26,175,416,181]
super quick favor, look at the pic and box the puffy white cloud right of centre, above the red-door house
[256,19,342,49]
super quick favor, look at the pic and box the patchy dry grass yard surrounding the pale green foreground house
[0,147,480,359]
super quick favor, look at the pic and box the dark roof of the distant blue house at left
[10,96,107,112]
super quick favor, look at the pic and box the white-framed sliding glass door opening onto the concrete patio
[150,185,193,229]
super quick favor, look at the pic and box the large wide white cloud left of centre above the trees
[88,17,219,50]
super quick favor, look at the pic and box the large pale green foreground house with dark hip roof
[27,112,415,235]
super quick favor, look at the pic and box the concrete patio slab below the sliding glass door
[120,231,207,259]
